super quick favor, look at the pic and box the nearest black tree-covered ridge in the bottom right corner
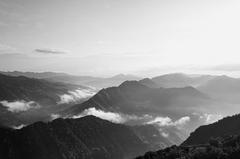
[136,135,240,159]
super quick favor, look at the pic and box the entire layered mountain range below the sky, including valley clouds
[0,72,240,159]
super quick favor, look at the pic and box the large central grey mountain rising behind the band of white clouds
[68,81,210,115]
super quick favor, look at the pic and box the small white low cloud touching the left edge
[0,100,40,113]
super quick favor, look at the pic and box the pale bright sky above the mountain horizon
[0,0,240,76]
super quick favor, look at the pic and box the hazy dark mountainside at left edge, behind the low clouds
[0,74,86,105]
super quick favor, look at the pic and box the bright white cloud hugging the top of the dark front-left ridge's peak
[72,108,126,123]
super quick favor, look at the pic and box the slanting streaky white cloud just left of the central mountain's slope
[58,89,96,104]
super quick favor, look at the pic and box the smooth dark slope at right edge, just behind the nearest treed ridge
[182,114,240,146]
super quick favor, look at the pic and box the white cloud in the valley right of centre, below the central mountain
[147,116,190,127]
